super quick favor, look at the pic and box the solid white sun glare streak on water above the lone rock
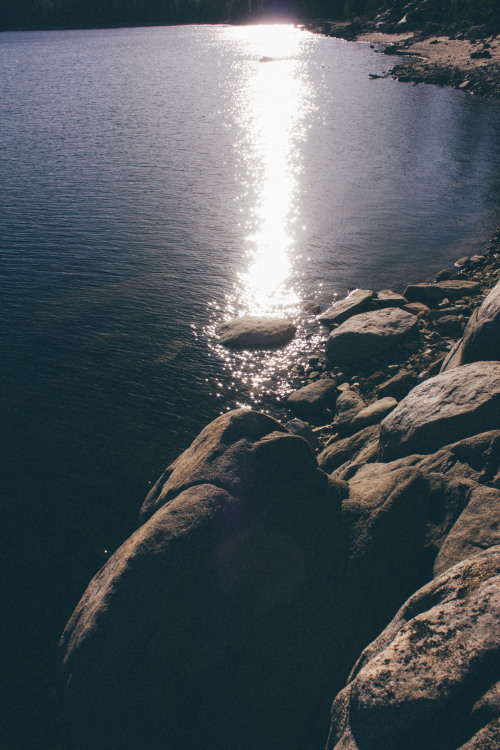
[234,26,306,315]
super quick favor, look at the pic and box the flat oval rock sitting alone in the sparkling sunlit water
[217,315,297,349]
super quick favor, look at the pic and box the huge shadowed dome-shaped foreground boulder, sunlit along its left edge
[61,410,340,750]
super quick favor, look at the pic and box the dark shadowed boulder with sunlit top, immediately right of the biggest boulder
[342,464,429,633]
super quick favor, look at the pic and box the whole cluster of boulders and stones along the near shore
[61,232,500,750]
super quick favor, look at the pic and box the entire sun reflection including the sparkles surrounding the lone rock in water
[209,25,324,408]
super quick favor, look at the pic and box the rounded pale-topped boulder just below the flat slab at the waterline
[326,307,418,365]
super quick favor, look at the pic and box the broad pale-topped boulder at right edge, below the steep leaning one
[380,362,500,461]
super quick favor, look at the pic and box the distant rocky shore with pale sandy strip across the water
[306,12,500,102]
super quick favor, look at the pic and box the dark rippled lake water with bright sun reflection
[0,25,500,624]
